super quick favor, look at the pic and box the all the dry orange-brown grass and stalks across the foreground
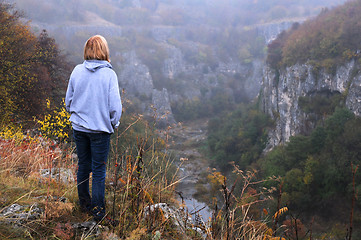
[0,123,282,240]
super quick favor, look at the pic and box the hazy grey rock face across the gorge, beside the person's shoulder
[114,29,264,123]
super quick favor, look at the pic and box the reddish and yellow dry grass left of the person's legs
[0,138,84,239]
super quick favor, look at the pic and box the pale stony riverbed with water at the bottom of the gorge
[165,120,211,222]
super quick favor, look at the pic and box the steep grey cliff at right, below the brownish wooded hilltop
[261,61,361,150]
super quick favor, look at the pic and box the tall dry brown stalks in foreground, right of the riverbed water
[206,164,282,240]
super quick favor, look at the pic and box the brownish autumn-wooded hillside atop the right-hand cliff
[267,1,361,70]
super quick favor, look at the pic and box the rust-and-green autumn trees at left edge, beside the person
[0,2,69,124]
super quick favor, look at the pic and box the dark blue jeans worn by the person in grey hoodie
[74,130,110,221]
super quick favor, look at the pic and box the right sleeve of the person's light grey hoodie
[109,73,122,129]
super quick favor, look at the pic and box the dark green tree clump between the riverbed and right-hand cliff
[208,104,272,172]
